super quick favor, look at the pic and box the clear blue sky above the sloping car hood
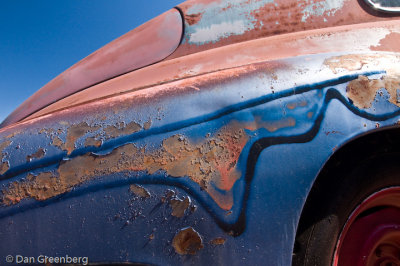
[0,0,184,121]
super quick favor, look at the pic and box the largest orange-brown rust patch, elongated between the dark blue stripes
[2,122,248,210]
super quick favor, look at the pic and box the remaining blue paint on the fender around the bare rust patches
[0,52,400,265]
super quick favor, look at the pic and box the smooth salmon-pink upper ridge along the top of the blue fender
[22,21,400,119]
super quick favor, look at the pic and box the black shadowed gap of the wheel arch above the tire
[292,126,400,265]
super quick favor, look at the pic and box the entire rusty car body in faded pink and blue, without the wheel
[0,0,400,265]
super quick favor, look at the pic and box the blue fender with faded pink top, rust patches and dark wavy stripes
[0,1,400,265]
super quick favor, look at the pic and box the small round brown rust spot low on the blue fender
[172,227,204,255]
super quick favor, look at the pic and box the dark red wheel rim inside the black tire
[333,187,400,266]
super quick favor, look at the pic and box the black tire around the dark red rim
[292,153,400,266]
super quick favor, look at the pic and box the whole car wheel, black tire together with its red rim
[293,155,400,266]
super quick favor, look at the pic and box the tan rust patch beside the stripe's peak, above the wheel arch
[346,75,400,109]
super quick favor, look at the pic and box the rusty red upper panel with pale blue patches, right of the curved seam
[171,0,396,57]
